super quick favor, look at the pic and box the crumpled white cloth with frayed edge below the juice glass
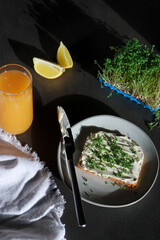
[0,129,65,240]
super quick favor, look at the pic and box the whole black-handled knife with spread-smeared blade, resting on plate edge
[57,106,86,227]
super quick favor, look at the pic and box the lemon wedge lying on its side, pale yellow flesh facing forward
[33,57,65,79]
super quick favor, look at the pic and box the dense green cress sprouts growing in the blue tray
[95,38,160,118]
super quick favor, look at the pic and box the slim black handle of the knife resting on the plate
[69,160,86,227]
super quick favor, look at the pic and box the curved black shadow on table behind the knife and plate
[31,95,117,178]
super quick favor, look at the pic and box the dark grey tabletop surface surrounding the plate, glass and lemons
[0,0,160,240]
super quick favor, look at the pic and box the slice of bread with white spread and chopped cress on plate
[77,131,144,187]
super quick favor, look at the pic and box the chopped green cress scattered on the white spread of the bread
[83,134,138,178]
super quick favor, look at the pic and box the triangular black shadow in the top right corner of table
[104,0,160,48]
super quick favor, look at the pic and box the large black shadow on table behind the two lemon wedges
[26,0,124,76]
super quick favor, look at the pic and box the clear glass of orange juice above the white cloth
[0,64,33,134]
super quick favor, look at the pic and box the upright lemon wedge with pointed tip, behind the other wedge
[57,42,73,68]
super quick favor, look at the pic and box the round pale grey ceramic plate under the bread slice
[58,115,159,207]
